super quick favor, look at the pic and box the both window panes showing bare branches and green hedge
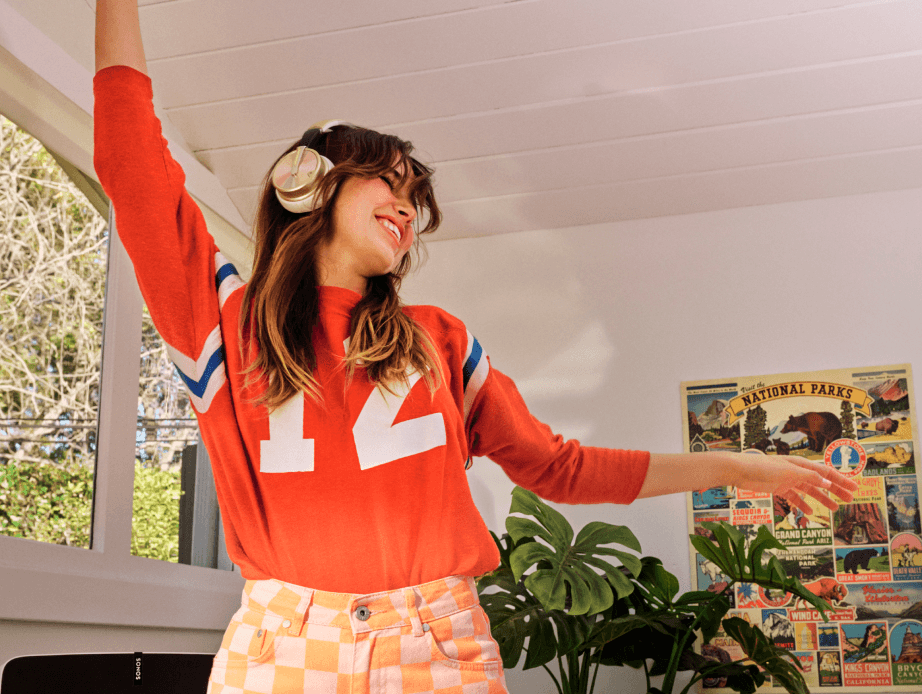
[0,116,233,569]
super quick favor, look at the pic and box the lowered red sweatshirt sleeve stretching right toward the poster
[464,333,650,504]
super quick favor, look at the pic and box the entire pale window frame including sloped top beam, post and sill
[0,19,250,631]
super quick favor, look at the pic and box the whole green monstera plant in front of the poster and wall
[478,487,831,694]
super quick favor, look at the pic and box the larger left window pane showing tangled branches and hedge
[0,116,108,549]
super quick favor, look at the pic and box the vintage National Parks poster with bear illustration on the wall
[682,364,922,692]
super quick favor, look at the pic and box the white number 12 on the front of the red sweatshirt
[259,373,445,472]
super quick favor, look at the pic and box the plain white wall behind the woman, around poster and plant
[404,184,922,692]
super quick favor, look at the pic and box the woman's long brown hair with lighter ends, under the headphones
[238,126,442,411]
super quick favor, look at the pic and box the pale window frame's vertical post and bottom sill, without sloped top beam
[0,214,244,629]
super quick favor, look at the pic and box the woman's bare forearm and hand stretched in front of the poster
[638,453,858,513]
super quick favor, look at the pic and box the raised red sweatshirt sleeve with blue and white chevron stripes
[93,65,242,413]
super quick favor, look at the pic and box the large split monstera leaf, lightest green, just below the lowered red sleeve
[506,487,641,615]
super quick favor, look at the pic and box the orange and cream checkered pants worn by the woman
[207,576,508,694]
